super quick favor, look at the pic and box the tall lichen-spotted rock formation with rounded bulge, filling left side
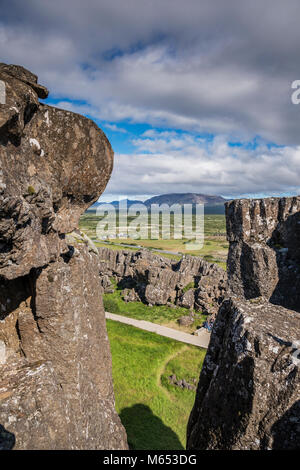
[0,64,127,449]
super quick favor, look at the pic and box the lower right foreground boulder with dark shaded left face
[188,298,300,450]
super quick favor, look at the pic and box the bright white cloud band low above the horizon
[105,131,300,197]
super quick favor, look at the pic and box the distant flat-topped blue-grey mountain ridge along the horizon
[90,193,227,214]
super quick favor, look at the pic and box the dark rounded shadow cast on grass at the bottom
[120,404,184,450]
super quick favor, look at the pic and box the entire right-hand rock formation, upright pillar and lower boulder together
[187,197,300,450]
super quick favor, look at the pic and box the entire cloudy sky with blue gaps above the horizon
[0,0,300,199]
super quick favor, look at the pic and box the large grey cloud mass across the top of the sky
[0,0,300,145]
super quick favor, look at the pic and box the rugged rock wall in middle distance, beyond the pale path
[99,248,226,314]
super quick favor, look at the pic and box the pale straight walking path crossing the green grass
[105,312,210,349]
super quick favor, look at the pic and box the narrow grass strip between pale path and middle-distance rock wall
[103,279,206,332]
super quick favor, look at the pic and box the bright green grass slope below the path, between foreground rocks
[107,320,206,450]
